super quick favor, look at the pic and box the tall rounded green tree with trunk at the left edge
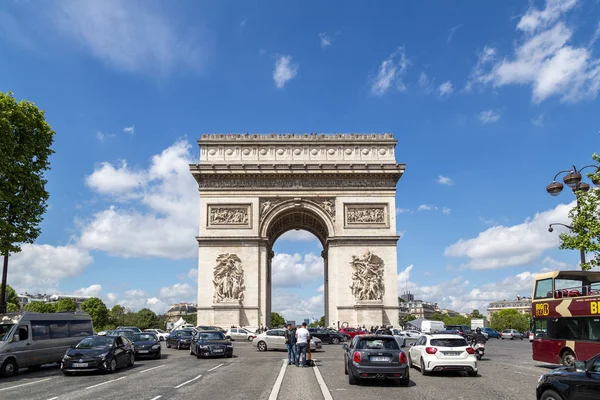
[0,92,55,313]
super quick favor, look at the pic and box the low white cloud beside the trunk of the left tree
[7,244,94,293]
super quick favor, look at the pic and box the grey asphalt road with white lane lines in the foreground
[0,339,551,400]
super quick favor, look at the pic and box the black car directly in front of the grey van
[60,336,135,375]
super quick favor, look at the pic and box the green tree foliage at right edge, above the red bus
[560,153,600,270]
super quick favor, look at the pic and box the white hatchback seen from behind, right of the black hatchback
[407,334,477,376]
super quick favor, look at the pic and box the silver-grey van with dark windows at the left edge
[0,312,94,377]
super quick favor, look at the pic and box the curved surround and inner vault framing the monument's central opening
[260,198,335,326]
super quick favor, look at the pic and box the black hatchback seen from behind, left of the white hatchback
[343,335,410,386]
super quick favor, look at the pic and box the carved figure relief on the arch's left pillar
[213,253,246,303]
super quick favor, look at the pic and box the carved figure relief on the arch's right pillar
[350,250,385,301]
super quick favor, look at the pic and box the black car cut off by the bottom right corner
[536,354,600,400]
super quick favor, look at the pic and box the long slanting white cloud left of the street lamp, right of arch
[444,202,575,270]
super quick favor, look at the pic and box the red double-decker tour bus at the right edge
[531,271,600,365]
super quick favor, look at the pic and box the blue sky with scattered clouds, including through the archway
[0,0,600,319]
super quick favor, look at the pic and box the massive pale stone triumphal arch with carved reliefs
[190,134,404,327]
